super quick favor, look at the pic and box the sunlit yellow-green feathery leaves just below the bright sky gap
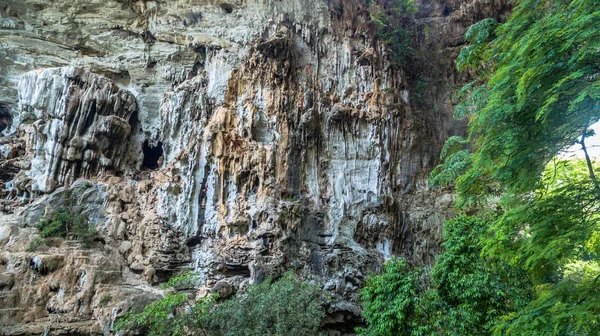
[486,160,600,283]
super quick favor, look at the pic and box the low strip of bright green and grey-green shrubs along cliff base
[115,272,324,336]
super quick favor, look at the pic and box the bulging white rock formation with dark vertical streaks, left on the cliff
[18,68,136,192]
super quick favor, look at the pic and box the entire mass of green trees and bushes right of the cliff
[360,0,600,336]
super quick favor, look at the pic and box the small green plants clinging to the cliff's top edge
[369,0,417,66]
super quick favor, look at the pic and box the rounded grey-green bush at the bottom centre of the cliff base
[210,272,324,336]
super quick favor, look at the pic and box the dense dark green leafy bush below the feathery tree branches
[430,215,532,335]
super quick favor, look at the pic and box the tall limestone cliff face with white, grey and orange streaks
[0,0,508,335]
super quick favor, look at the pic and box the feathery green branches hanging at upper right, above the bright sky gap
[457,0,600,197]
